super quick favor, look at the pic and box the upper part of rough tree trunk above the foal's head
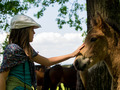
[86,0,120,30]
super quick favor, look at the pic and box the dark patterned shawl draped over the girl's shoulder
[0,44,29,72]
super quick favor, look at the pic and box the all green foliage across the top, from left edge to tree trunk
[0,0,85,54]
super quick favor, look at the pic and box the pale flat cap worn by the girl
[10,15,41,29]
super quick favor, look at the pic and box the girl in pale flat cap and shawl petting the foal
[0,15,84,90]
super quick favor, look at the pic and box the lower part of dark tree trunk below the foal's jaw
[87,62,112,90]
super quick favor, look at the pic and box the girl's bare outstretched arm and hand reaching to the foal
[32,44,84,66]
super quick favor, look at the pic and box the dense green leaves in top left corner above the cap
[0,0,29,31]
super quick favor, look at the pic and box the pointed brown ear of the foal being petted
[90,12,104,27]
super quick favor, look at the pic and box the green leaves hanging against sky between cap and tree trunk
[24,0,85,31]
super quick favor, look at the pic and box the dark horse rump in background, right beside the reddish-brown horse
[42,65,63,90]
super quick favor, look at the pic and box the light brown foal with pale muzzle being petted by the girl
[74,14,120,90]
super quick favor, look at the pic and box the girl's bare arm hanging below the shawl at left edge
[0,70,9,90]
